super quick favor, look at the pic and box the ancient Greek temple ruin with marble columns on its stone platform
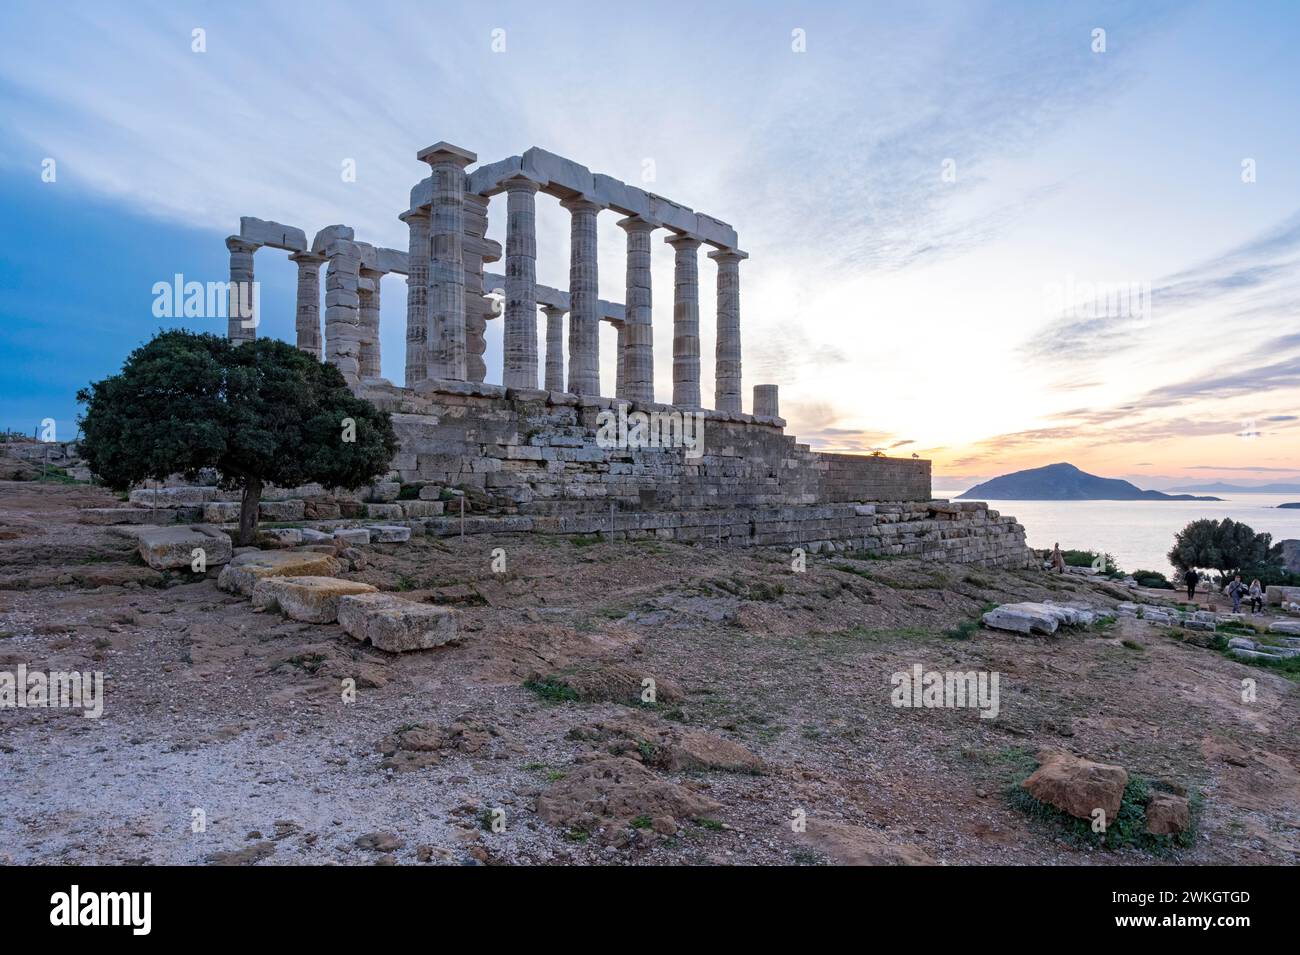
[226,143,1028,567]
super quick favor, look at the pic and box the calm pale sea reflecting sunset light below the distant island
[933,489,1300,576]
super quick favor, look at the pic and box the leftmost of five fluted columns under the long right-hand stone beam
[501,175,538,388]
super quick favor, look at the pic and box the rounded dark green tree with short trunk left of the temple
[77,331,397,543]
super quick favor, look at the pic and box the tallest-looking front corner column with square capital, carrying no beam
[416,143,478,381]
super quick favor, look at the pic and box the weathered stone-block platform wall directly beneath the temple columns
[360,382,930,515]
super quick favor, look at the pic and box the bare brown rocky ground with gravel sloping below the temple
[0,482,1300,865]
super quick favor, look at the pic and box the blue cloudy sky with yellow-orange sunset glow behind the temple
[0,0,1300,489]
